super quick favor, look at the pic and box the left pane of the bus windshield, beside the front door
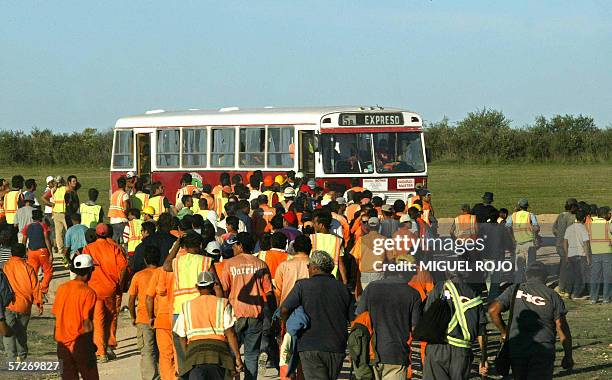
[320,133,374,174]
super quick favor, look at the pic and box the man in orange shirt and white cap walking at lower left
[51,255,99,380]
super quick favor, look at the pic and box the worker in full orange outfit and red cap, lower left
[83,223,127,362]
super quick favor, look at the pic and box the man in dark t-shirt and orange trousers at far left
[22,209,53,297]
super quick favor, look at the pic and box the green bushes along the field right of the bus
[425,108,612,162]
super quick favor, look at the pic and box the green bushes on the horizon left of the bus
[0,128,113,167]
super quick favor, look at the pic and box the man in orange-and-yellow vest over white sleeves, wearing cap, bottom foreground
[174,272,243,380]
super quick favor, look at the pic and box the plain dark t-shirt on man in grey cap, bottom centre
[282,275,350,353]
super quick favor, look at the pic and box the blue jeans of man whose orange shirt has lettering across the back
[234,317,263,380]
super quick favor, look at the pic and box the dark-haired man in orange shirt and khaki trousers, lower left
[128,246,159,380]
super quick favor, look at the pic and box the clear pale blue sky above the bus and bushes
[0,0,612,131]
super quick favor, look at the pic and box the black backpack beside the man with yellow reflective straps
[413,292,452,344]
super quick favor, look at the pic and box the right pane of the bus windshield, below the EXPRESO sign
[374,132,425,173]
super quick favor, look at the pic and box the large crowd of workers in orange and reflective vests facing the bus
[0,171,612,380]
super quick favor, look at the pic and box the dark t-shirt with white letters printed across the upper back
[497,282,567,357]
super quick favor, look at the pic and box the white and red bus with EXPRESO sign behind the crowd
[111,106,427,203]
